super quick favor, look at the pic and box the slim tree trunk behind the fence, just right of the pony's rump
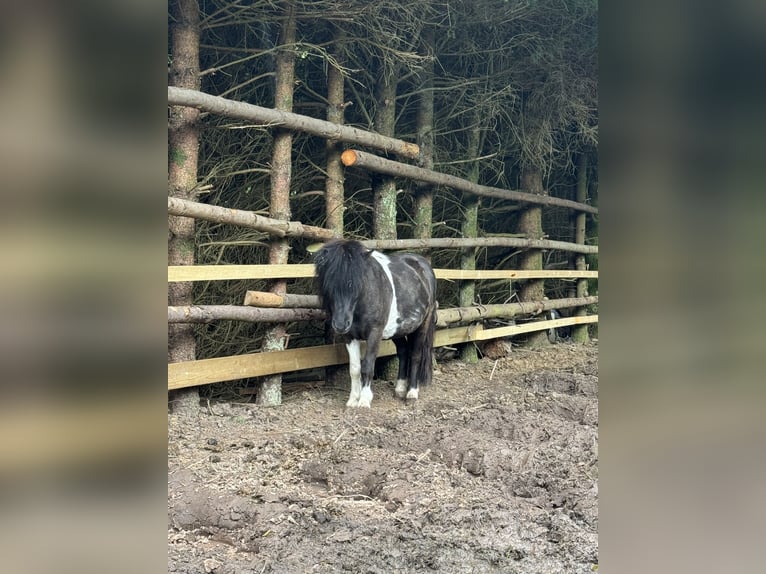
[458,113,481,363]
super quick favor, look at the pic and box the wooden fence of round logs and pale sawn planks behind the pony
[168,88,598,390]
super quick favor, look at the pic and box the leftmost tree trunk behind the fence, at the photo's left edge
[168,0,200,415]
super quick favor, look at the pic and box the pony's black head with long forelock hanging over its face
[314,239,369,335]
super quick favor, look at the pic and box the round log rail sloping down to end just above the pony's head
[168,197,338,241]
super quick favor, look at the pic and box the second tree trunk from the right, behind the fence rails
[518,166,549,347]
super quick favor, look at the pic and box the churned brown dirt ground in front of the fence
[168,343,598,574]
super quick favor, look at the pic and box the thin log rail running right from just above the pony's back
[359,237,598,253]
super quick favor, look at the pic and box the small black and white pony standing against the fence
[314,239,438,407]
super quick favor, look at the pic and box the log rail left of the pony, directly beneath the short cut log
[168,305,326,323]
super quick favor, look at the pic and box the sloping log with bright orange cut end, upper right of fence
[340,149,598,213]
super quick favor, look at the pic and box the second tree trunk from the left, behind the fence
[256,1,295,406]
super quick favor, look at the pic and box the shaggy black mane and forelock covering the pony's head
[314,239,367,312]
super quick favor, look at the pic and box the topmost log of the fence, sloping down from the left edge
[168,87,420,159]
